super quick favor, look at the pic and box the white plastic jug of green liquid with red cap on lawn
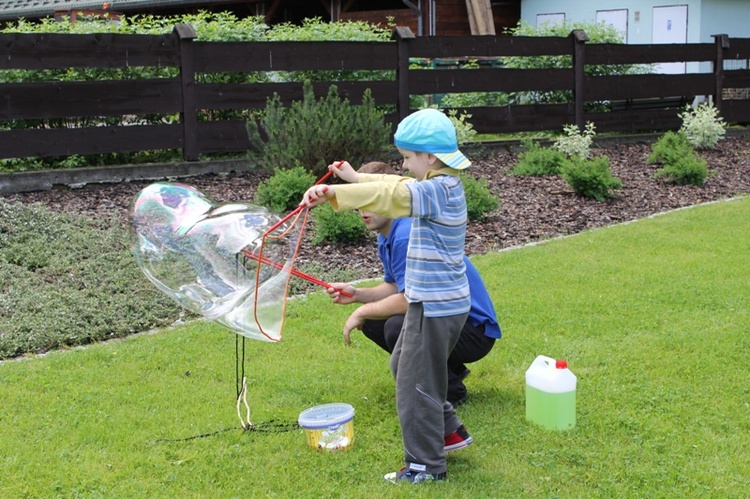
[526,355,577,430]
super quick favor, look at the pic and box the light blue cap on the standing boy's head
[393,109,471,170]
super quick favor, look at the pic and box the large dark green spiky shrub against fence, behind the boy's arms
[253,82,391,176]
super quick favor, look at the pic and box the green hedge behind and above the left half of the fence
[0,11,395,171]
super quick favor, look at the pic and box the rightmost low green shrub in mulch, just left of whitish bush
[648,131,709,186]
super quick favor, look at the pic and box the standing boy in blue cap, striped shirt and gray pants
[302,109,471,483]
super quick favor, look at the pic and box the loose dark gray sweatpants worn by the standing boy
[391,303,469,473]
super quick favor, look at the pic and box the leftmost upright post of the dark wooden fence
[173,24,198,161]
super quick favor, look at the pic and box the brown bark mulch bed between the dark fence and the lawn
[4,137,750,284]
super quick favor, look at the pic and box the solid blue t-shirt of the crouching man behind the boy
[378,218,502,339]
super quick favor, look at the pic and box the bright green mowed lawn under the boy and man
[0,198,750,498]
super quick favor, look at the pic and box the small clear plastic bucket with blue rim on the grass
[299,403,354,451]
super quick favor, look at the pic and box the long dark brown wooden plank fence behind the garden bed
[0,25,750,161]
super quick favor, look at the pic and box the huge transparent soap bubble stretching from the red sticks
[132,183,301,341]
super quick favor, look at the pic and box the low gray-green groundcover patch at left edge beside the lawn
[0,199,182,359]
